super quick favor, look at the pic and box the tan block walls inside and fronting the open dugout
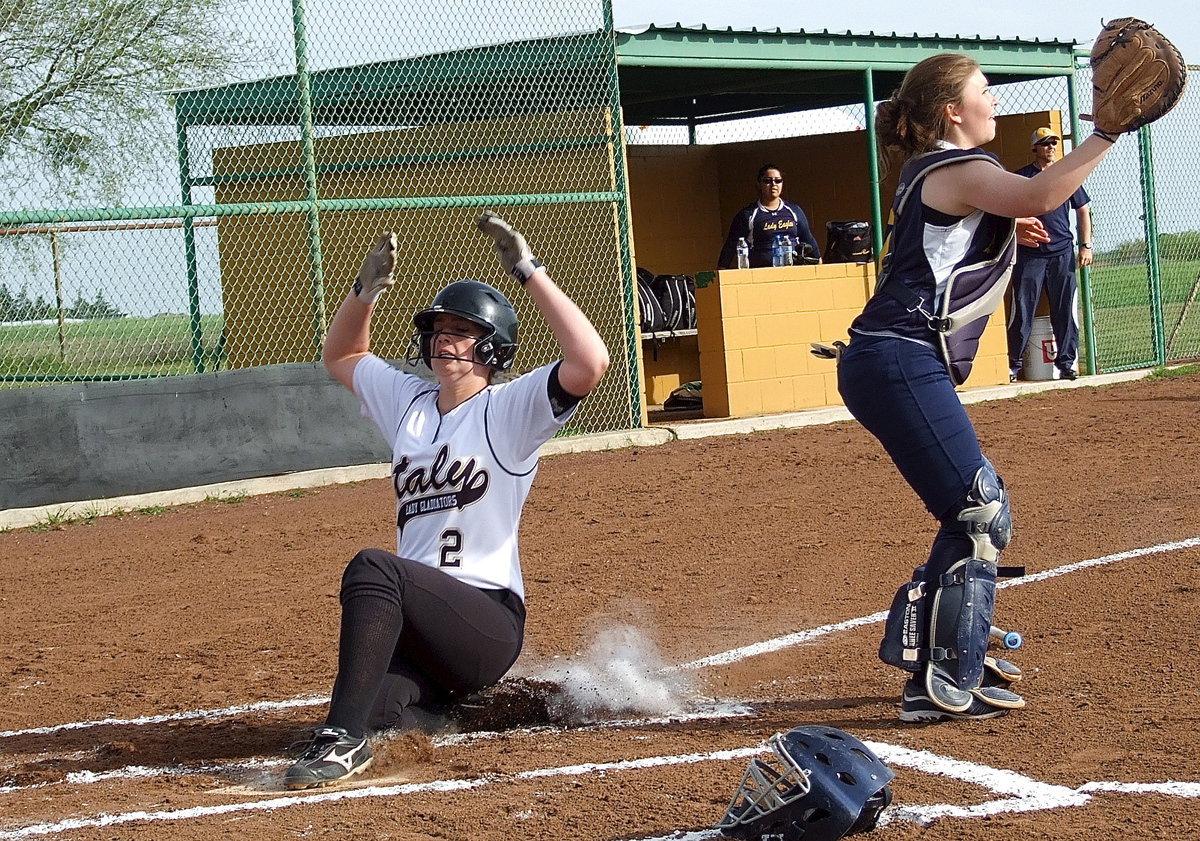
[629,112,1062,418]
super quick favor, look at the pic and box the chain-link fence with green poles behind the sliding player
[0,0,641,432]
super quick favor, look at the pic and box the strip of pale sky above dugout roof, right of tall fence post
[613,0,1200,64]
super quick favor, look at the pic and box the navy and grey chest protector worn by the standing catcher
[876,151,1016,385]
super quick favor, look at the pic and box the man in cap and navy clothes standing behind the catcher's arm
[1008,128,1092,382]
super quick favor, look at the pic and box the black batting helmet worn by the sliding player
[409,281,517,371]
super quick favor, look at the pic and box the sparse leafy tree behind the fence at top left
[0,0,244,196]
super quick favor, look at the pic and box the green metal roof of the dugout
[173,24,1075,126]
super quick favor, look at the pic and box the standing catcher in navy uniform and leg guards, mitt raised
[838,18,1184,721]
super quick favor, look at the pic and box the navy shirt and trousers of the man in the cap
[1008,163,1091,376]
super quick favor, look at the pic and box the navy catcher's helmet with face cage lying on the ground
[716,726,895,841]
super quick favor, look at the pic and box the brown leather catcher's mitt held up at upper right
[1091,18,1188,142]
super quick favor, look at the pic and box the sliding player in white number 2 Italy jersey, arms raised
[284,212,608,789]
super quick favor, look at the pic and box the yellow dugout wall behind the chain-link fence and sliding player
[212,110,631,428]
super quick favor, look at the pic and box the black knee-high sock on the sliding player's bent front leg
[325,595,404,738]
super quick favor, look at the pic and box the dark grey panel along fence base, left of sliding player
[0,362,391,510]
